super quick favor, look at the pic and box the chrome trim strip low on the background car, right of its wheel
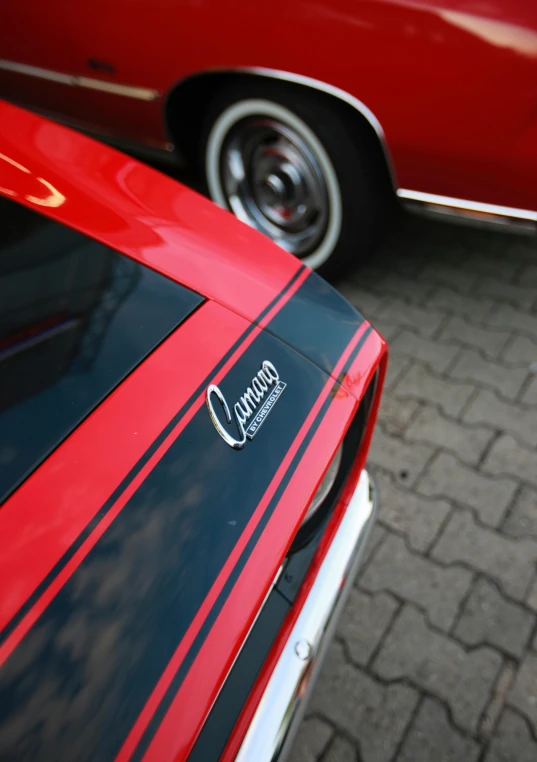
[397,188,537,224]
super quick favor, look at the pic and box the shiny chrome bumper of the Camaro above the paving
[235,470,377,762]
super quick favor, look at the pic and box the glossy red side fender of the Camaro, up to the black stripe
[0,102,300,320]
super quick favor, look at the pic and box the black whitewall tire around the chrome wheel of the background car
[200,79,393,277]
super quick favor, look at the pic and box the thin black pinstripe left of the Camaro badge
[0,266,305,645]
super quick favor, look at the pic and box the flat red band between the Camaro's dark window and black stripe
[0,302,247,663]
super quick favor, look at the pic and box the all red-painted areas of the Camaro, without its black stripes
[0,104,386,762]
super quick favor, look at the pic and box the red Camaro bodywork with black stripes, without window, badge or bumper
[0,104,386,762]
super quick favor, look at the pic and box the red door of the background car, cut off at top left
[0,0,78,121]
